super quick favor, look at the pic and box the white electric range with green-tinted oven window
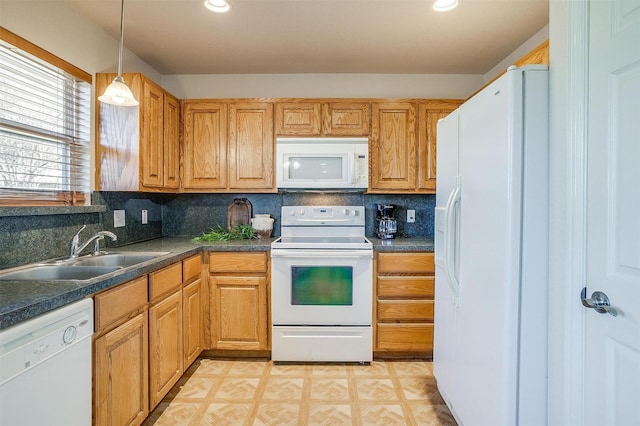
[271,206,373,362]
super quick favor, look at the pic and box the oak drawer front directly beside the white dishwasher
[94,276,147,334]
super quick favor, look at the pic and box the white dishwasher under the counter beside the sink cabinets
[0,299,93,426]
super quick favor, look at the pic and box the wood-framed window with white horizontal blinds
[0,27,91,206]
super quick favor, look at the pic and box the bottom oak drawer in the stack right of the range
[376,324,433,352]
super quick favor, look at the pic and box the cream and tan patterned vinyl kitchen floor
[144,358,456,426]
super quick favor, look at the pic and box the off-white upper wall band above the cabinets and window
[0,0,549,99]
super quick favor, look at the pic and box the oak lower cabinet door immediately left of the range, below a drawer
[209,275,267,350]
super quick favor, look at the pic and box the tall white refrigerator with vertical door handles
[433,65,549,426]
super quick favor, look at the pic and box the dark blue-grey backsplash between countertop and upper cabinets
[0,192,435,269]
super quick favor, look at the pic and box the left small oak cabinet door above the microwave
[275,102,322,136]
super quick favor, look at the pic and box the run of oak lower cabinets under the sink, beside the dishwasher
[94,254,204,426]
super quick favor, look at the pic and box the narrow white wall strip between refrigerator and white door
[548,0,585,426]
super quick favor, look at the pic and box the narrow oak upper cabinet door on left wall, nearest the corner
[163,93,180,189]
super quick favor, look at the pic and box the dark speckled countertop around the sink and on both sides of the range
[0,237,433,329]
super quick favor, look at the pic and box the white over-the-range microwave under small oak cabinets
[276,137,369,189]
